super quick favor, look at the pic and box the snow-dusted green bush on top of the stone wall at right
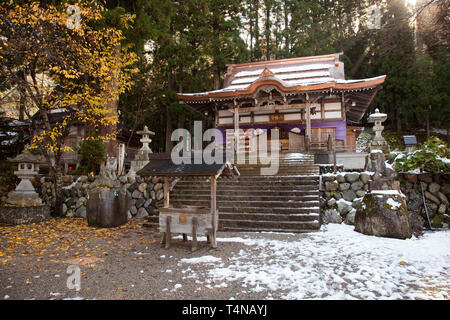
[393,137,450,173]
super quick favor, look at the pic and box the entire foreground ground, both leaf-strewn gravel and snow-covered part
[0,218,450,300]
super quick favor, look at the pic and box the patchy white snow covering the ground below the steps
[179,224,450,299]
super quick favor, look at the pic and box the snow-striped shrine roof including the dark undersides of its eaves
[177,53,386,122]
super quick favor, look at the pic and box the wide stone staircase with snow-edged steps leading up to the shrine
[146,153,320,232]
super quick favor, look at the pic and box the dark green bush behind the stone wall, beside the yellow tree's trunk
[74,139,106,175]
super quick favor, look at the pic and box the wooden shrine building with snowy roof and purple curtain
[178,53,386,152]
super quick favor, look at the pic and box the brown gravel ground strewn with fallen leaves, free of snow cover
[0,219,285,300]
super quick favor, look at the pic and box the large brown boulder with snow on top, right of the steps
[355,190,413,239]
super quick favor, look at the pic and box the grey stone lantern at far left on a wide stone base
[0,151,50,224]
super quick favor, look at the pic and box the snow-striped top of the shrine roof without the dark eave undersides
[178,53,386,103]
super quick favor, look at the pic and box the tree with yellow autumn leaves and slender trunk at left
[0,1,136,215]
